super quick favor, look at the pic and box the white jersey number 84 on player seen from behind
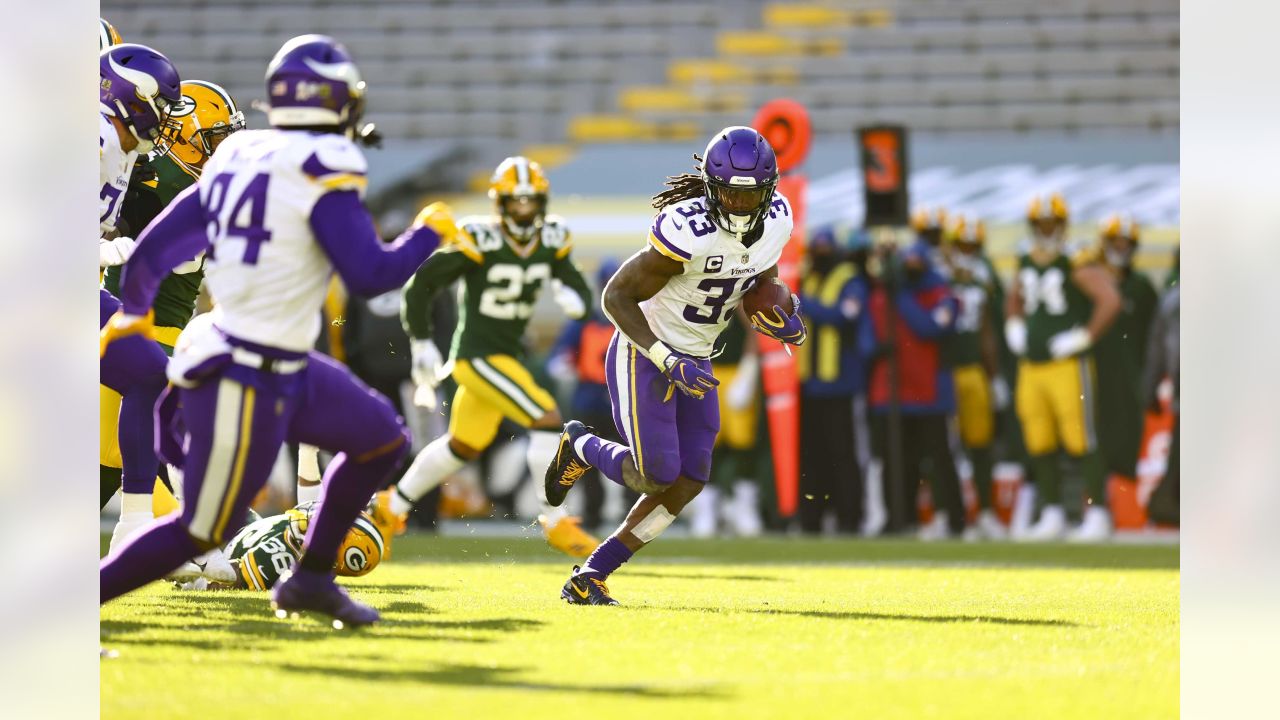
[200,129,367,352]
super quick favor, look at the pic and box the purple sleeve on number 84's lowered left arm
[120,184,209,315]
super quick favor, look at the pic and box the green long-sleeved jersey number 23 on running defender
[401,215,591,360]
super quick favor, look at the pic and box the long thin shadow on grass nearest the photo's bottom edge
[279,662,727,700]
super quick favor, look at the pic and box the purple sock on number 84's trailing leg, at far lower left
[97,515,200,602]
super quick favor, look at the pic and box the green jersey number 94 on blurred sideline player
[1016,254,1093,363]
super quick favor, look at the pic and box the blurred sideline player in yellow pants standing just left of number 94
[943,215,1009,539]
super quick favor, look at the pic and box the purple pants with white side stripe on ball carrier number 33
[604,333,719,484]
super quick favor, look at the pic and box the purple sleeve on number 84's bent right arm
[311,190,440,297]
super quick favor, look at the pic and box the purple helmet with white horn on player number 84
[266,35,365,137]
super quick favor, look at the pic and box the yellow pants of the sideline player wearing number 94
[1015,355,1098,456]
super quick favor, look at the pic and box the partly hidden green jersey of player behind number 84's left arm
[102,151,205,335]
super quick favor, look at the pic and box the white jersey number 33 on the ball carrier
[640,192,794,357]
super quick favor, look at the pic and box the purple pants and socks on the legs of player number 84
[99,342,408,602]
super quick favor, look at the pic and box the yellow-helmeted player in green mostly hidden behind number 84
[99,79,244,525]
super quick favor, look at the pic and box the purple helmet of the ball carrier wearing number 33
[703,126,778,234]
